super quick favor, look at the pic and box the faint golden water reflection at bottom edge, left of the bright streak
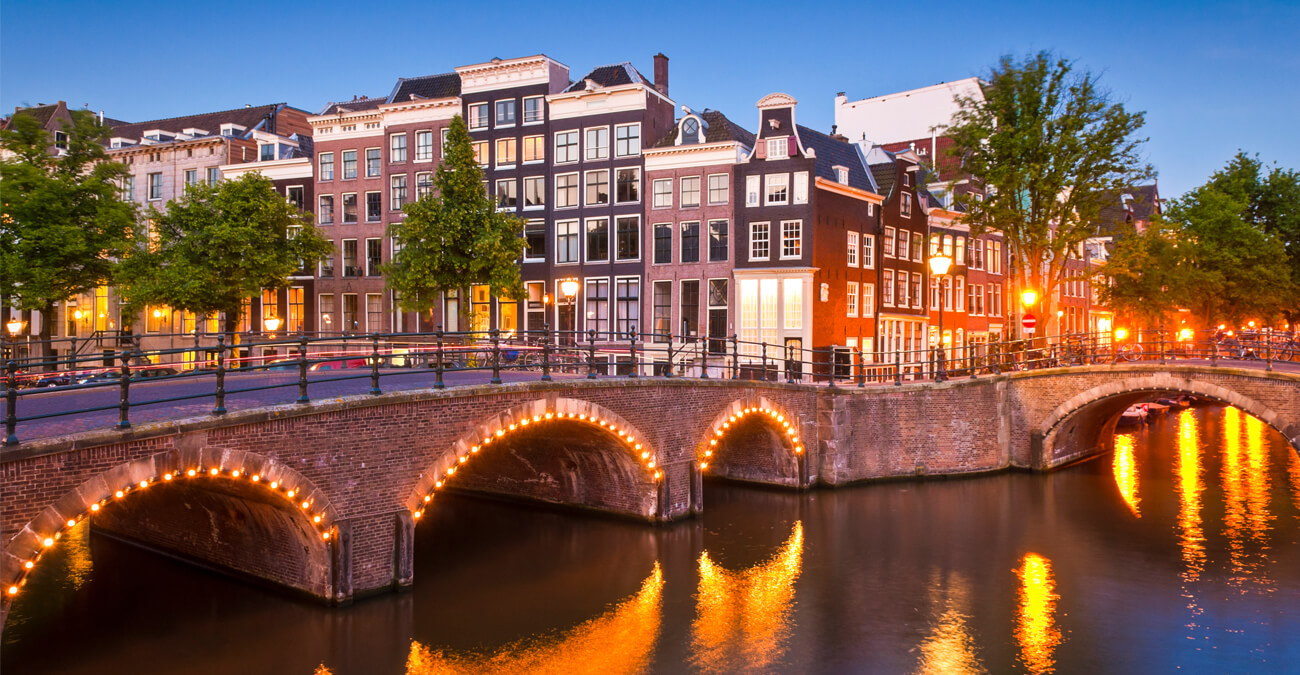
[915,574,987,674]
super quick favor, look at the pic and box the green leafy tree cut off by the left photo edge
[0,111,135,351]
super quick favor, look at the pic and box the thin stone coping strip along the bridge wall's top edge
[0,363,1300,462]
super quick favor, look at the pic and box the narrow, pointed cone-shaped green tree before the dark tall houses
[382,116,524,326]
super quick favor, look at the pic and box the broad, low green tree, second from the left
[118,173,333,333]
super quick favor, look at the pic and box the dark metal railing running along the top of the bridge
[3,325,1300,445]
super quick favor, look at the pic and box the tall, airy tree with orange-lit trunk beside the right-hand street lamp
[946,52,1153,335]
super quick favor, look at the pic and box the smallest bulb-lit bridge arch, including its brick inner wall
[696,397,806,486]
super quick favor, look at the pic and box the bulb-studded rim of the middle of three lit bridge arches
[406,397,663,520]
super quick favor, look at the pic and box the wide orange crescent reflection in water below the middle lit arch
[407,563,663,675]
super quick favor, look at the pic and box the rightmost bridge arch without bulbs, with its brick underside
[1035,373,1300,468]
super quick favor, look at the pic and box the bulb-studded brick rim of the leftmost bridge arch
[0,449,338,609]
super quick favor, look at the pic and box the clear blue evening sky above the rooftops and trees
[0,0,1300,196]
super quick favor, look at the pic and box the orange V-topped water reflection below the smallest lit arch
[692,523,803,672]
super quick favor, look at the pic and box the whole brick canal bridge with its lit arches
[0,364,1300,615]
